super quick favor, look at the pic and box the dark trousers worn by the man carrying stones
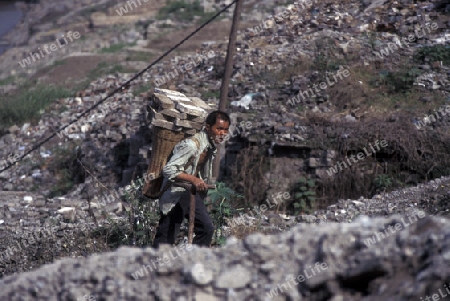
[153,192,214,248]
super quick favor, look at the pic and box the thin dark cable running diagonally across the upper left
[0,0,237,173]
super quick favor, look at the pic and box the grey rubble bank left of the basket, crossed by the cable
[0,74,148,190]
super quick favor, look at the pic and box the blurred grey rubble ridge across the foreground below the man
[0,212,450,301]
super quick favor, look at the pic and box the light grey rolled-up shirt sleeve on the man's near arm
[162,139,197,181]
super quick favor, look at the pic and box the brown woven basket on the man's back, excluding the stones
[142,127,185,195]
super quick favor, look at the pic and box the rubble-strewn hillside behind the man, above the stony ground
[0,1,450,207]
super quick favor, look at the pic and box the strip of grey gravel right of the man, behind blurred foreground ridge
[227,172,450,231]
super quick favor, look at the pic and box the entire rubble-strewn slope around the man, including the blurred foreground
[0,0,450,301]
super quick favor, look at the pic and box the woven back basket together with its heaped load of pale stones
[142,89,212,199]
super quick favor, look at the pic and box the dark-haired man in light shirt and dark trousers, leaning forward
[153,111,230,248]
